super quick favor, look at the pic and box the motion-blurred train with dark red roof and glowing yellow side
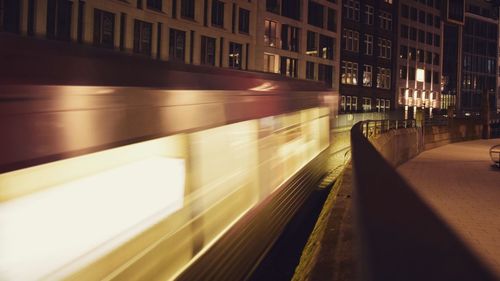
[0,34,337,280]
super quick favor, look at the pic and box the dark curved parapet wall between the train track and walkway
[351,122,496,281]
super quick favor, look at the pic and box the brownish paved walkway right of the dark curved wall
[397,139,500,276]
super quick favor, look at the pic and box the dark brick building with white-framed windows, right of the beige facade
[340,0,397,112]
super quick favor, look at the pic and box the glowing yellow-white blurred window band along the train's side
[0,107,330,280]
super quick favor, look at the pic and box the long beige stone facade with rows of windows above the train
[0,0,340,94]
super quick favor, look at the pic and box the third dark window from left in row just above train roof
[94,9,115,48]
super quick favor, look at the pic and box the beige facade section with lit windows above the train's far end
[256,0,340,90]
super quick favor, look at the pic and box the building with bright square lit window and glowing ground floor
[396,0,443,118]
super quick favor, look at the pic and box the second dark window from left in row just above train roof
[47,0,73,41]
